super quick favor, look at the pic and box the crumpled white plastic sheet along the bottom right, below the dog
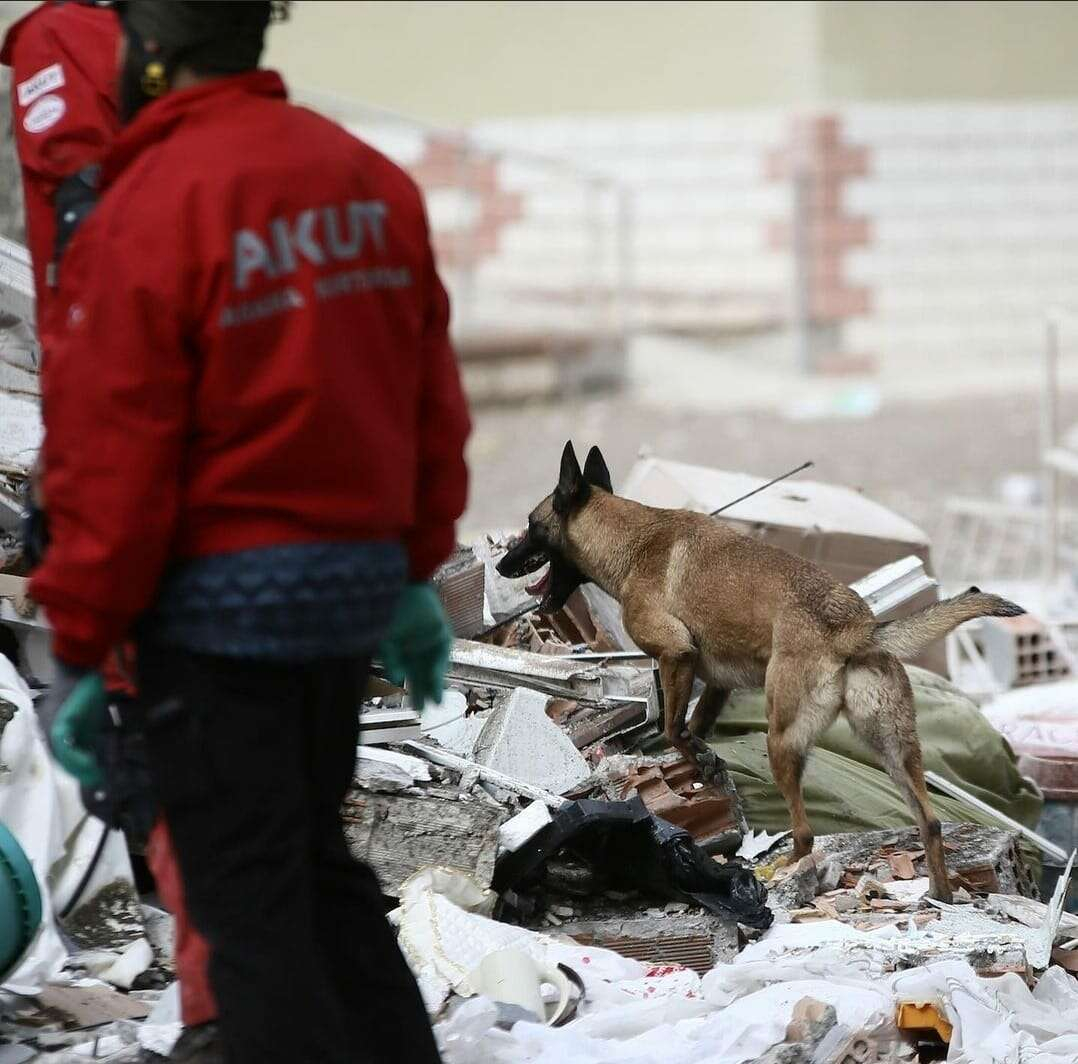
[427,881,1078,1064]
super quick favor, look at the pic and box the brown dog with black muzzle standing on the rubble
[498,443,1024,901]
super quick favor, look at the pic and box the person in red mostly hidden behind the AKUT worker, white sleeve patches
[0,2,220,1064]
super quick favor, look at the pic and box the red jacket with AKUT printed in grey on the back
[31,70,469,665]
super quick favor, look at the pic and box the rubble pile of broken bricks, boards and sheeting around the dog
[0,461,1078,1064]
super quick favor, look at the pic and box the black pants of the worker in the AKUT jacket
[139,646,439,1064]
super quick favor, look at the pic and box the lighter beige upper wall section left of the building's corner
[268,0,817,123]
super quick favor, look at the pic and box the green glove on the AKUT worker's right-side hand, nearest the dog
[381,583,453,711]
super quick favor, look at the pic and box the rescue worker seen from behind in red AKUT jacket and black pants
[31,0,469,1064]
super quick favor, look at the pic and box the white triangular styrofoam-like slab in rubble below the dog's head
[475,688,591,794]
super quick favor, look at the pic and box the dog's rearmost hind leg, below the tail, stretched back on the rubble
[845,651,952,902]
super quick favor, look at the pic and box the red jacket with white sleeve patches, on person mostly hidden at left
[0,3,120,344]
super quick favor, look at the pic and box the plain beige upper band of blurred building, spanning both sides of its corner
[263,0,1078,123]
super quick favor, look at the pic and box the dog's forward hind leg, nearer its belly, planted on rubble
[764,657,842,858]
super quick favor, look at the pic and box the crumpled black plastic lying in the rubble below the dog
[492,798,772,928]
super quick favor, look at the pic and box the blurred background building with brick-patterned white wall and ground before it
[6,0,1078,556]
